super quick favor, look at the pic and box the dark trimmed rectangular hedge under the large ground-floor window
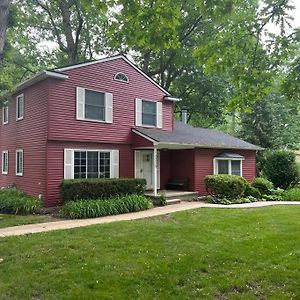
[60,178,146,202]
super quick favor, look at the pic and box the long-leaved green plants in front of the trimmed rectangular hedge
[60,195,152,219]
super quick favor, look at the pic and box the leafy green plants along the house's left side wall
[0,189,42,215]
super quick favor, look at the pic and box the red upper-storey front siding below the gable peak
[49,58,173,144]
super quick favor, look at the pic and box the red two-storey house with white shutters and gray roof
[0,56,260,206]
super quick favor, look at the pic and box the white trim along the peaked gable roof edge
[55,55,171,95]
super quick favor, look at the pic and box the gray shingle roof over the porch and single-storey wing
[134,121,262,150]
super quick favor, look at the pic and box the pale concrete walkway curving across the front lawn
[0,201,300,237]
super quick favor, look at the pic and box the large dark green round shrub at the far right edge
[262,150,300,189]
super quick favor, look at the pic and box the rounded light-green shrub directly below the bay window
[204,175,247,199]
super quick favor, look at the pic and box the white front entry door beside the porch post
[135,150,160,189]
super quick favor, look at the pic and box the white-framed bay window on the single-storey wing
[214,153,244,176]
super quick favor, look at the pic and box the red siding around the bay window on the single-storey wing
[195,149,256,195]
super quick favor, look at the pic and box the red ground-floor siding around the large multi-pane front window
[46,141,134,206]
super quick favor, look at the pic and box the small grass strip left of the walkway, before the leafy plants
[0,214,52,228]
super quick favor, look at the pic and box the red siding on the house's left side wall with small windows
[0,81,48,196]
